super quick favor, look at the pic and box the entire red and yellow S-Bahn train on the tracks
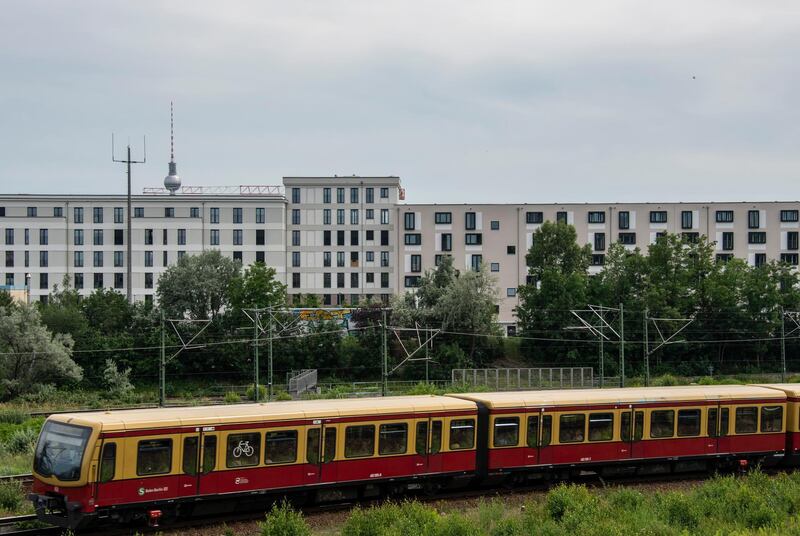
[29,384,800,529]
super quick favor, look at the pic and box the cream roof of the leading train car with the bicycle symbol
[51,395,476,431]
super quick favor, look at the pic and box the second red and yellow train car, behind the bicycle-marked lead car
[450,385,788,481]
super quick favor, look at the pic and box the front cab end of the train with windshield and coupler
[28,416,99,529]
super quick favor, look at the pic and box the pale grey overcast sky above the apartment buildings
[0,0,800,202]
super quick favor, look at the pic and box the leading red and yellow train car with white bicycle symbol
[30,396,478,529]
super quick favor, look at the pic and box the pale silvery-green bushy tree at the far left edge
[0,305,83,399]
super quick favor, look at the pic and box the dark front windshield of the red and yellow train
[33,421,92,481]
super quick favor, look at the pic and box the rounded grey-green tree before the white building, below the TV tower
[156,249,240,319]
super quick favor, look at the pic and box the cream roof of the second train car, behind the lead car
[449,385,788,409]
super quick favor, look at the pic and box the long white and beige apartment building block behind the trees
[0,176,800,332]
